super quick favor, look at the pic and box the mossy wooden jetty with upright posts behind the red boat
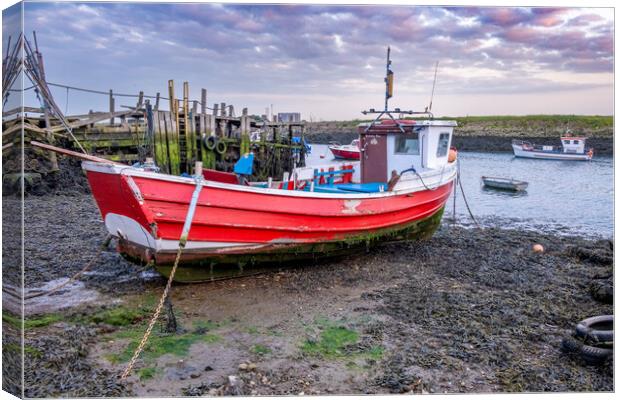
[2,80,305,184]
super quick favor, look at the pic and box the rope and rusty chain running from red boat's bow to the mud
[121,177,203,379]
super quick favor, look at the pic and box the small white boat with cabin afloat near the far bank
[512,135,594,161]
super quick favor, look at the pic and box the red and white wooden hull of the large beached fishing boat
[84,164,455,281]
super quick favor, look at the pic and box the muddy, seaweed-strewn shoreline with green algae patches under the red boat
[3,193,614,397]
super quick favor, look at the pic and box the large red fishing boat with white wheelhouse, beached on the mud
[82,51,457,281]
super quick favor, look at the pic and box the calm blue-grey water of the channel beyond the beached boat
[307,144,614,238]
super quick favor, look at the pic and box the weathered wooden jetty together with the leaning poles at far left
[2,32,306,191]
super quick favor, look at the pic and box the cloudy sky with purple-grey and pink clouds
[3,2,614,120]
